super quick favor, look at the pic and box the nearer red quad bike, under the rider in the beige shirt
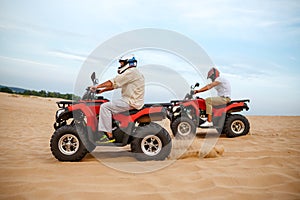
[50,73,172,161]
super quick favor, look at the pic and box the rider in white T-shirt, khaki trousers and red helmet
[194,67,231,127]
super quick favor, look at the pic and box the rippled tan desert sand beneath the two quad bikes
[0,93,300,200]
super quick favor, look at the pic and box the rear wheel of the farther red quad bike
[223,114,250,138]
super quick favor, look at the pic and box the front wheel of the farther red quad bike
[171,116,197,139]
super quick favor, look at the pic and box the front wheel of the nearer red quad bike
[50,125,88,162]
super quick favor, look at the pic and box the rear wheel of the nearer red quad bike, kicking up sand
[131,123,172,161]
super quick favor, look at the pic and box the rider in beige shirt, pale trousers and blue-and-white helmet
[91,55,145,143]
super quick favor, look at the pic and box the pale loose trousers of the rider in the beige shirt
[98,99,131,133]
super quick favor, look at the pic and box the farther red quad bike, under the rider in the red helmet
[168,83,250,138]
